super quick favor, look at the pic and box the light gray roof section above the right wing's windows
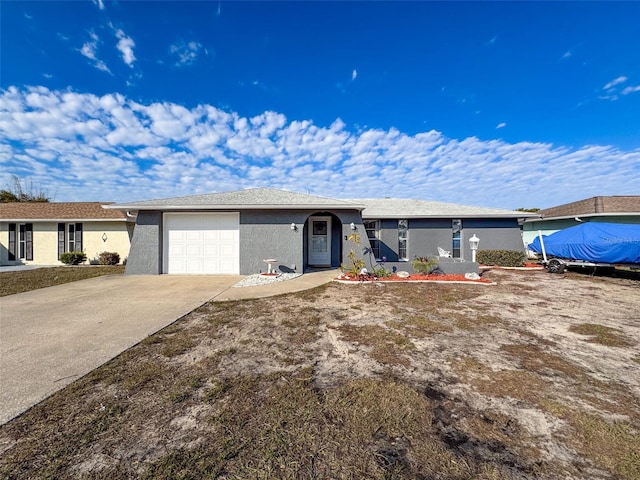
[352,198,537,219]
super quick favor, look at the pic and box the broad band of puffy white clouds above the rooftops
[0,87,640,208]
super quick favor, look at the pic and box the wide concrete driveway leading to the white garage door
[0,275,243,424]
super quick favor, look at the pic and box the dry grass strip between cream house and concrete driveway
[0,265,124,297]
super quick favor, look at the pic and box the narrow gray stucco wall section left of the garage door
[125,212,162,275]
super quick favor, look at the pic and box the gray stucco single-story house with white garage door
[105,188,527,275]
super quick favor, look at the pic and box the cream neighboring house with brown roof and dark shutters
[0,202,135,265]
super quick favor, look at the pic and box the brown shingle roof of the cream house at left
[0,202,128,222]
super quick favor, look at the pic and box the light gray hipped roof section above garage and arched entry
[106,188,364,210]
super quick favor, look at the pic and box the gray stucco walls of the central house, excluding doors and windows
[126,210,524,275]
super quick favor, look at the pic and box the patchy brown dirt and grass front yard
[0,270,640,479]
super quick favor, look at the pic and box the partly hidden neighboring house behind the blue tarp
[522,195,640,245]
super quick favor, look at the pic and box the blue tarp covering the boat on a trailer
[529,222,640,264]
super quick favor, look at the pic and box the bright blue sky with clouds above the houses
[0,0,640,208]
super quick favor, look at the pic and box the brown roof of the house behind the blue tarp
[538,195,640,219]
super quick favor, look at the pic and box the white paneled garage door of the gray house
[164,213,240,275]
